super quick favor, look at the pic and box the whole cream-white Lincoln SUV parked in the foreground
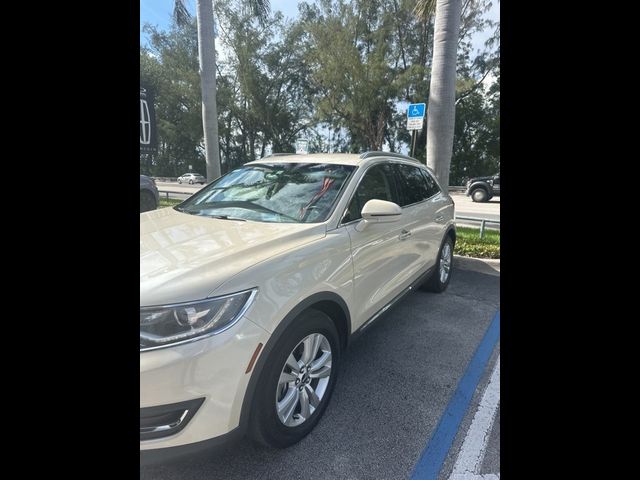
[140,152,456,463]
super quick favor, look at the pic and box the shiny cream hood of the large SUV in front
[140,208,326,306]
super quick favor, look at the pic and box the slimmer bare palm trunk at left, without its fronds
[196,0,220,182]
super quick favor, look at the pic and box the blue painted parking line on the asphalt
[411,311,500,480]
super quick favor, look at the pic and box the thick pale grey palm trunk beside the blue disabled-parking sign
[427,0,462,191]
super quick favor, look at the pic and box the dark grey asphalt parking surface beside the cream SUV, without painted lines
[140,261,500,480]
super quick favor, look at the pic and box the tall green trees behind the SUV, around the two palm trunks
[140,0,500,178]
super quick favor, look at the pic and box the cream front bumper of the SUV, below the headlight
[140,318,269,461]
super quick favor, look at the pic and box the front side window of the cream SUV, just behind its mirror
[342,164,398,223]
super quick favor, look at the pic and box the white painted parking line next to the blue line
[449,355,500,480]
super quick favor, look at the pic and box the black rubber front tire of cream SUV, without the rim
[249,309,340,448]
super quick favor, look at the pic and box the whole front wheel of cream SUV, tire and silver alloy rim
[250,309,340,448]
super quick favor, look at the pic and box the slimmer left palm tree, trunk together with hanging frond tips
[173,0,270,182]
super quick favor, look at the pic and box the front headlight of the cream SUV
[140,288,258,351]
